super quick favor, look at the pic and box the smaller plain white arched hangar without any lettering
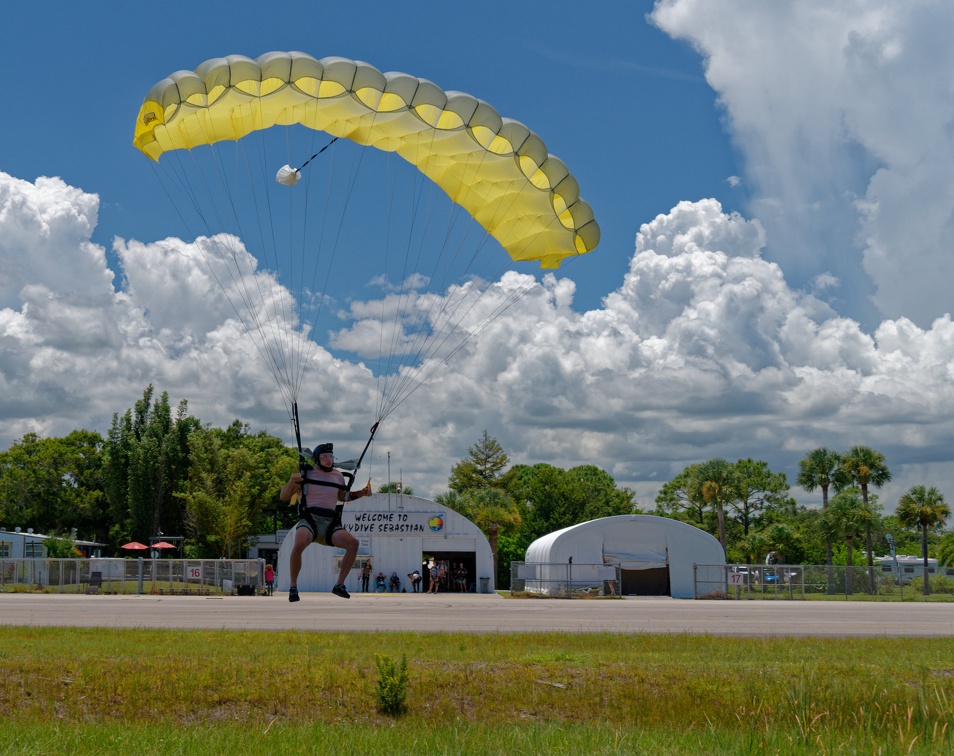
[523,515,725,598]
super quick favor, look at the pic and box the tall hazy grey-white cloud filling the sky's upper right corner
[651,0,954,328]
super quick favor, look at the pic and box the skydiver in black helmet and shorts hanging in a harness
[279,444,371,601]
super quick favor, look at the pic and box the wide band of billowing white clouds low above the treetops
[0,174,954,508]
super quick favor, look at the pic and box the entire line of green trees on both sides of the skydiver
[0,386,954,589]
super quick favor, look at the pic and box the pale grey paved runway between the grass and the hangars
[0,593,954,637]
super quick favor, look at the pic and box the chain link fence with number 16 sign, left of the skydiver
[0,558,264,595]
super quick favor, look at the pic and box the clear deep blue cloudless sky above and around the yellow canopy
[0,2,740,314]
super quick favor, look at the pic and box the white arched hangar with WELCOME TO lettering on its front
[276,493,494,593]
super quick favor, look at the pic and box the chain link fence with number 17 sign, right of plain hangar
[693,564,950,601]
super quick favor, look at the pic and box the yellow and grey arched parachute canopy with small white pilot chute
[133,52,600,268]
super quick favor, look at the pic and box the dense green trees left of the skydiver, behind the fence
[0,385,298,558]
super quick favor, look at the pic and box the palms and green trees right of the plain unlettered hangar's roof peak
[656,445,954,593]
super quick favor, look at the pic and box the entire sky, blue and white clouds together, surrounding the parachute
[0,0,954,510]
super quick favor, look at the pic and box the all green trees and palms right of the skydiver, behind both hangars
[437,430,954,593]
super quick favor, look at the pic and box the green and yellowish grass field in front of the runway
[0,627,954,756]
